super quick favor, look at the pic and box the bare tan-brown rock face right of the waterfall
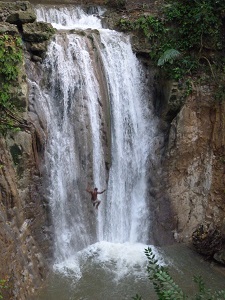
[163,86,225,241]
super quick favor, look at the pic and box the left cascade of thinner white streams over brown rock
[29,35,108,261]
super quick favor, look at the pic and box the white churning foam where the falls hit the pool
[54,241,165,281]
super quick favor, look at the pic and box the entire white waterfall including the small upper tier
[31,7,160,272]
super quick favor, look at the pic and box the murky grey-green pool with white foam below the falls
[32,242,225,300]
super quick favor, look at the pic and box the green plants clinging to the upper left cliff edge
[0,34,26,133]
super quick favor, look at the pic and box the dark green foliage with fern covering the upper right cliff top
[120,0,225,96]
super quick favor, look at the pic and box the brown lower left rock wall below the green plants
[0,132,48,300]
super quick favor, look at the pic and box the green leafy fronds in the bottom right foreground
[132,248,225,300]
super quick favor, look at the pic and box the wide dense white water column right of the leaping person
[101,31,155,243]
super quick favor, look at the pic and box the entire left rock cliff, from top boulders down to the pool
[0,2,52,300]
